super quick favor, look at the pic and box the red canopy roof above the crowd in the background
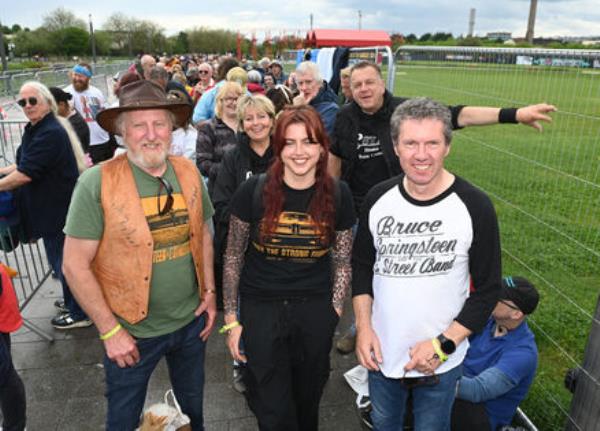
[306,29,392,48]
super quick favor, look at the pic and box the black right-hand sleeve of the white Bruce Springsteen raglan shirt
[456,177,502,332]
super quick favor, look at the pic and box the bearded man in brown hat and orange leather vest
[63,80,216,430]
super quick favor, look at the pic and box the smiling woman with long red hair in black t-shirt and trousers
[223,106,355,431]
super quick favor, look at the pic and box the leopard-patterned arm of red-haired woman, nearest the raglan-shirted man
[331,229,352,316]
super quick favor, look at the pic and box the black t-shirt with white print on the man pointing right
[349,109,390,209]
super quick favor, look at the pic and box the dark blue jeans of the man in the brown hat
[104,315,206,431]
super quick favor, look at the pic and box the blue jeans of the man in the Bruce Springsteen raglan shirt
[369,366,462,431]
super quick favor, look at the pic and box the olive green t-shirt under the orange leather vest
[64,162,214,338]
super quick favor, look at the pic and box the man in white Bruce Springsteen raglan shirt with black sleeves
[352,99,501,431]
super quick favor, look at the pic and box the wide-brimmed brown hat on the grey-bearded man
[96,80,193,135]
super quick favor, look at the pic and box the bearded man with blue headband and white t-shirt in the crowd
[65,63,115,164]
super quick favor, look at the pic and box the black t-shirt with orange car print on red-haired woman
[231,176,356,299]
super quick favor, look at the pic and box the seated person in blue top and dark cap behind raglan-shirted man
[452,277,539,431]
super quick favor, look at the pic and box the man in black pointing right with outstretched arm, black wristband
[328,61,556,353]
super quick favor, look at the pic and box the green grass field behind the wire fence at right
[394,62,600,430]
